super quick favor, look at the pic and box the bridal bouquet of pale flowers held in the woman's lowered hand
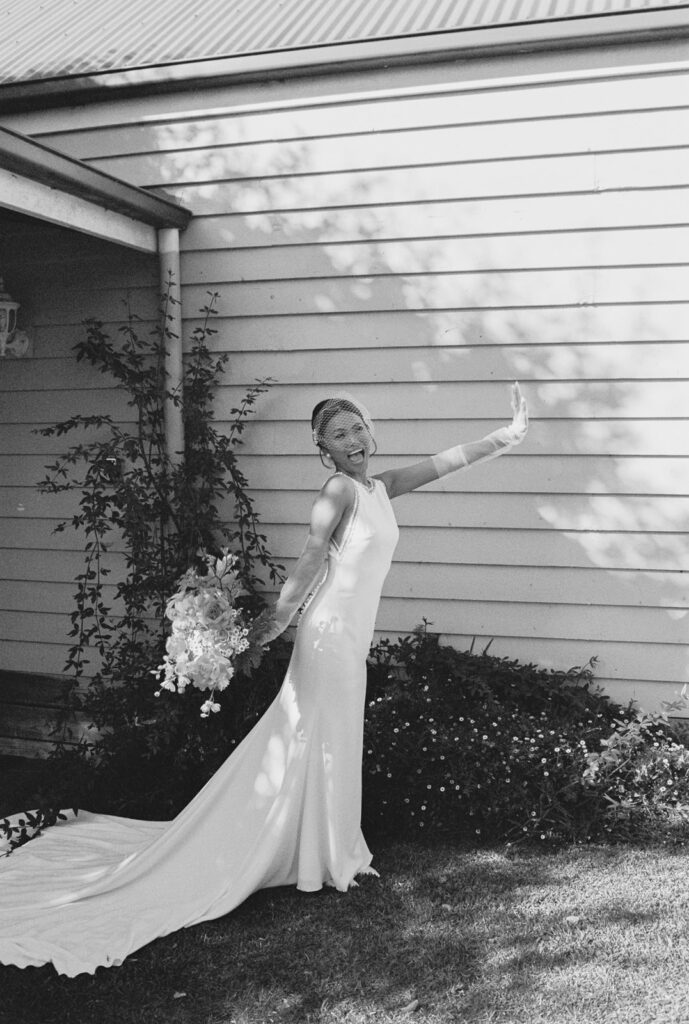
[154,549,249,718]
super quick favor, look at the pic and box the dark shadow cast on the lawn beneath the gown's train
[0,844,550,1024]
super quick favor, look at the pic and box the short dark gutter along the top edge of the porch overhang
[0,128,191,229]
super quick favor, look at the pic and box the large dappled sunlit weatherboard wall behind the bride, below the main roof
[2,37,689,720]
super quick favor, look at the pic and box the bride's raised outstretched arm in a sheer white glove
[377,382,528,498]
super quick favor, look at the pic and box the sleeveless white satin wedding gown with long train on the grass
[0,480,398,976]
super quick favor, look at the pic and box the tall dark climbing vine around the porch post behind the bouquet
[6,281,286,818]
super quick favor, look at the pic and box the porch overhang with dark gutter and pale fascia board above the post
[0,128,191,253]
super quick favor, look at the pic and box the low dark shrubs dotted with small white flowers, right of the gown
[363,628,689,842]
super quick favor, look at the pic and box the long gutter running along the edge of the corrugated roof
[0,3,689,116]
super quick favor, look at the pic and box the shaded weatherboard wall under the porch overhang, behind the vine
[0,216,158,708]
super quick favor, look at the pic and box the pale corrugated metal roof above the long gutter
[0,0,689,83]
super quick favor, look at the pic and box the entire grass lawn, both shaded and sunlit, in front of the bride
[0,843,689,1024]
